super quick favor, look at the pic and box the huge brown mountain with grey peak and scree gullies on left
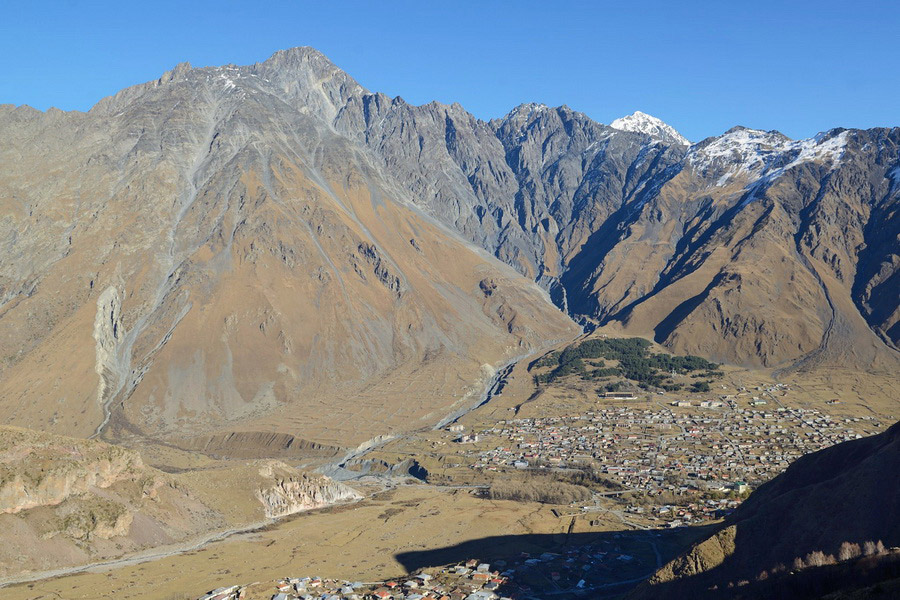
[0,50,578,446]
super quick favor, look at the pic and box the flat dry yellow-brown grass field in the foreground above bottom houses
[0,485,622,600]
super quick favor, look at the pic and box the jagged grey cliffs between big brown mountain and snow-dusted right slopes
[336,94,683,312]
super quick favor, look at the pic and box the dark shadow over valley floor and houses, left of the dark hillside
[395,521,711,599]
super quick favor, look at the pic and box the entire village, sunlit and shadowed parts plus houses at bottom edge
[186,384,882,600]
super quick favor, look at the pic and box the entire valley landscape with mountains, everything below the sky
[0,47,900,598]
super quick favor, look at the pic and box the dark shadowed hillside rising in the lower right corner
[629,423,900,600]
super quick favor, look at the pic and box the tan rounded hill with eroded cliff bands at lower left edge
[0,427,214,576]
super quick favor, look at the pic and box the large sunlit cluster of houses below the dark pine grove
[472,404,880,502]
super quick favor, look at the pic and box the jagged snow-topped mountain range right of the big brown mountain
[336,89,900,369]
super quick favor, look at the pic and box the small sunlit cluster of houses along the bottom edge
[193,560,509,600]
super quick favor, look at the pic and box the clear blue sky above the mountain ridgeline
[0,0,900,140]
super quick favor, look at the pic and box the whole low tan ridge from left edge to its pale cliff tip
[0,427,359,578]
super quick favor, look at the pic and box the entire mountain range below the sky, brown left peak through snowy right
[0,48,900,447]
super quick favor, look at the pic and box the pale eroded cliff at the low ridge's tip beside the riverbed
[257,462,362,518]
